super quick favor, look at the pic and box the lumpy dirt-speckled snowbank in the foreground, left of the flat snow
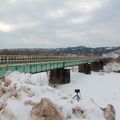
[0,72,109,120]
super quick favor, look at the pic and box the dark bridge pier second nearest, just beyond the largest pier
[79,63,91,74]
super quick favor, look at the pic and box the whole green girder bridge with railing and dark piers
[0,55,103,84]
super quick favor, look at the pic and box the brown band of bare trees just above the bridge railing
[0,49,101,58]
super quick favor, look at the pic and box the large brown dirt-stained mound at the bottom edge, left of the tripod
[31,98,64,120]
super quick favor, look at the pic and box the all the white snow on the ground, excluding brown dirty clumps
[0,64,120,120]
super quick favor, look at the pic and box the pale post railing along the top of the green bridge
[0,55,96,64]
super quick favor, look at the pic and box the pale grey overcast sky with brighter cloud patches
[0,0,120,49]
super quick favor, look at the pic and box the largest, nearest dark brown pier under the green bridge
[49,68,70,84]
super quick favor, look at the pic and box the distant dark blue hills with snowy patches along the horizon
[0,46,120,55]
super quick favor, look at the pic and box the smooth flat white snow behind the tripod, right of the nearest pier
[58,72,120,120]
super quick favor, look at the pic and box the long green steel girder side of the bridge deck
[0,59,95,78]
